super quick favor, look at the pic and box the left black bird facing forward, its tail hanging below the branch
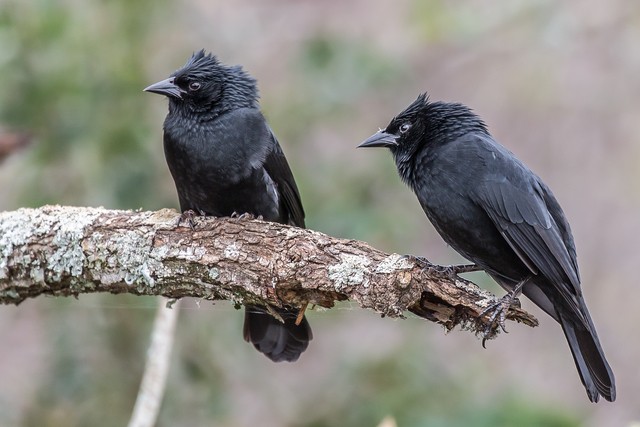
[145,50,312,362]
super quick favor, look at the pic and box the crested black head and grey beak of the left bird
[144,49,258,110]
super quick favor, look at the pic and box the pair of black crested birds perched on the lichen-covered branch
[145,50,616,402]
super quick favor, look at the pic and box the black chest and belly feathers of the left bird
[164,111,278,218]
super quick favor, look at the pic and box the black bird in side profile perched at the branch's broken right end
[359,94,616,402]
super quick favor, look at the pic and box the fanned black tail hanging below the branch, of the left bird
[243,305,313,362]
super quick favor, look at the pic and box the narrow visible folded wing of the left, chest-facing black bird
[264,130,305,228]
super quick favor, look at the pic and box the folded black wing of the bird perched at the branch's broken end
[472,138,586,323]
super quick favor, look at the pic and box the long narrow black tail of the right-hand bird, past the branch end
[559,310,616,402]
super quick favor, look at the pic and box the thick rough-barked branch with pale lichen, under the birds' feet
[0,206,537,342]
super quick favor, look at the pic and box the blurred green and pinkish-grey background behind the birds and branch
[0,0,640,427]
